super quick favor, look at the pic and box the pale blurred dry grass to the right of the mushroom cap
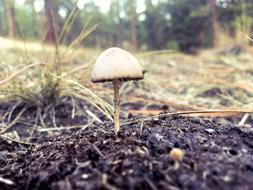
[141,51,253,109]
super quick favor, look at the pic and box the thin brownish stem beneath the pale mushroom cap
[113,79,120,134]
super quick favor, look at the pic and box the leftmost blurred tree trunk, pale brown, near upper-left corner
[5,0,17,38]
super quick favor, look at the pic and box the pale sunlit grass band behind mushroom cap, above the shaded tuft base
[0,42,253,109]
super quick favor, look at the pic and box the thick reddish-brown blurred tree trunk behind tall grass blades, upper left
[44,0,57,44]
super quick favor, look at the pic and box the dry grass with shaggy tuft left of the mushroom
[0,38,112,142]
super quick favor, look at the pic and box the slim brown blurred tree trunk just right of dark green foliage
[208,0,219,47]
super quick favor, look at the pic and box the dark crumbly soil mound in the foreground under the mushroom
[0,116,253,190]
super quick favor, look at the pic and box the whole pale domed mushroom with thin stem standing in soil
[92,47,144,134]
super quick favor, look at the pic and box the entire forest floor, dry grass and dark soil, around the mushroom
[0,39,253,190]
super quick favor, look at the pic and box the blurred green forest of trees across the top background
[0,0,253,53]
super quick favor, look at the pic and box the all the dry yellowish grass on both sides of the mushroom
[0,36,253,142]
